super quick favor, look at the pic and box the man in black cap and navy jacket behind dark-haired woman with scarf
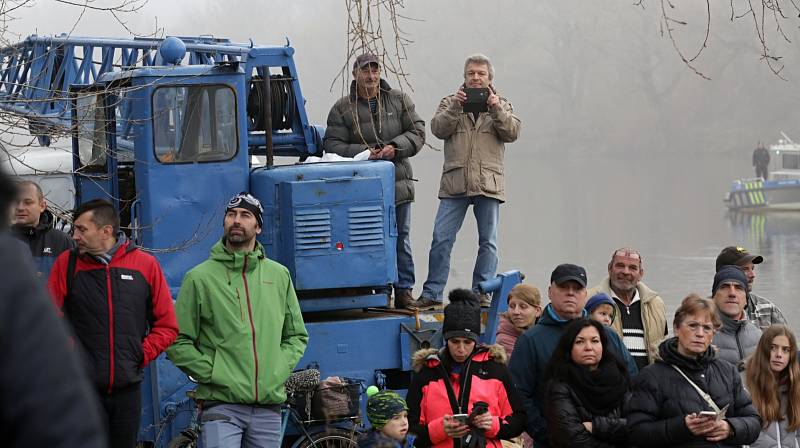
[508,263,638,448]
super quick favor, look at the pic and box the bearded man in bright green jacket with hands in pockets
[167,193,308,448]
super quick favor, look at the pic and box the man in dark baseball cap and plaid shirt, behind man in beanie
[716,246,788,330]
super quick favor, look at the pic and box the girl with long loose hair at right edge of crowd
[745,325,800,448]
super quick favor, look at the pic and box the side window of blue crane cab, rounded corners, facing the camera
[153,85,238,163]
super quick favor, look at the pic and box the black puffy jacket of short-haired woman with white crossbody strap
[625,338,761,447]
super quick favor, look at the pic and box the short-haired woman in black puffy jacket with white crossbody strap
[625,294,761,447]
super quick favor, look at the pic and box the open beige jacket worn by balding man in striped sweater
[587,277,667,364]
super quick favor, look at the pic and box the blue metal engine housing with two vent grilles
[250,161,397,294]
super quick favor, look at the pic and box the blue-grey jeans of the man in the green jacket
[201,403,281,448]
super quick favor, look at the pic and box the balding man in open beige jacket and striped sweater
[589,247,667,369]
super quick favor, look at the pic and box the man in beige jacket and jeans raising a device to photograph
[416,54,521,308]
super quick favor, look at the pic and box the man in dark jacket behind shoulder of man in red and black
[11,180,75,280]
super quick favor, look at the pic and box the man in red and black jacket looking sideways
[48,199,178,448]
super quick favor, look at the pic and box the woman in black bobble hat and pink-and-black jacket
[406,289,525,448]
